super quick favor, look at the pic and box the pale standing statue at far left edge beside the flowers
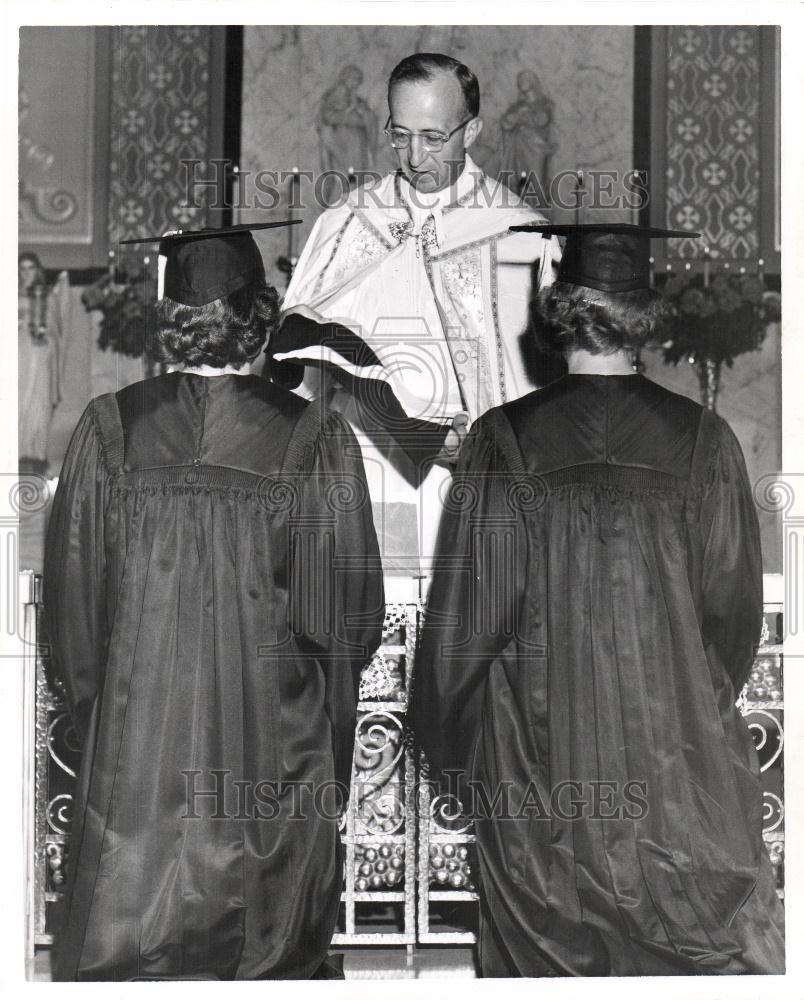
[17,253,70,475]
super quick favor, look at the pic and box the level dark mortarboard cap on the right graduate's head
[511,222,701,292]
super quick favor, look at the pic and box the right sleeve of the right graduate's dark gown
[701,419,763,693]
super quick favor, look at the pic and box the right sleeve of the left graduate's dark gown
[290,413,385,787]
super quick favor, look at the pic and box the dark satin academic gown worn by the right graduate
[411,375,783,976]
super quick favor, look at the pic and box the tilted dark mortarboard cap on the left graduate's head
[121,219,301,306]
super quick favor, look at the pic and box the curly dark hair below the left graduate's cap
[154,281,279,368]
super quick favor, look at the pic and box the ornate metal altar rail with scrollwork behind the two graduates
[20,573,784,957]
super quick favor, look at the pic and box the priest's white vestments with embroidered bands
[273,157,559,591]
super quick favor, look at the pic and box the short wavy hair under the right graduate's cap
[531,281,670,355]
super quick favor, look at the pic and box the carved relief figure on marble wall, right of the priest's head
[500,69,556,193]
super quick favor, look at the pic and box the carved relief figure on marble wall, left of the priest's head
[316,64,377,203]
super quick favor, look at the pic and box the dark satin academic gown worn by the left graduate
[45,373,384,980]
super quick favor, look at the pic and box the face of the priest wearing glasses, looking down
[389,73,481,193]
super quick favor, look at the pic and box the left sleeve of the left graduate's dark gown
[44,403,107,739]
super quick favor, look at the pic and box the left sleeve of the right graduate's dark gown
[409,413,529,790]
